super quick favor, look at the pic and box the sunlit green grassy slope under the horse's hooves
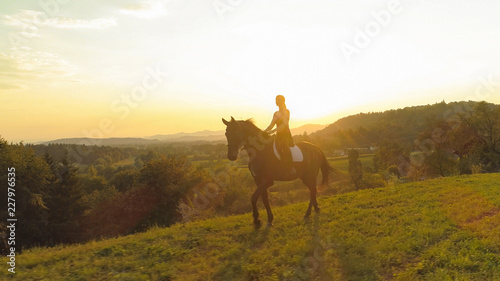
[4,174,500,280]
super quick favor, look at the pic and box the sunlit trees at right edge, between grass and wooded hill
[340,102,500,186]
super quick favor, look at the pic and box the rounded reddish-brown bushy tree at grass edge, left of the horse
[85,156,209,238]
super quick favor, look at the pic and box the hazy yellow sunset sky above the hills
[0,0,500,142]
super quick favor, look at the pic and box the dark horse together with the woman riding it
[222,95,333,228]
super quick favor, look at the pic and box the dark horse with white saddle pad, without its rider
[222,117,335,228]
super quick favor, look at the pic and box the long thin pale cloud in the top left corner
[2,10,117,29]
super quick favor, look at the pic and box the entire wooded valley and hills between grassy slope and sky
[0,101,500,251]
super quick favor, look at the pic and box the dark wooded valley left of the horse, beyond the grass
[0,138,232,251]
